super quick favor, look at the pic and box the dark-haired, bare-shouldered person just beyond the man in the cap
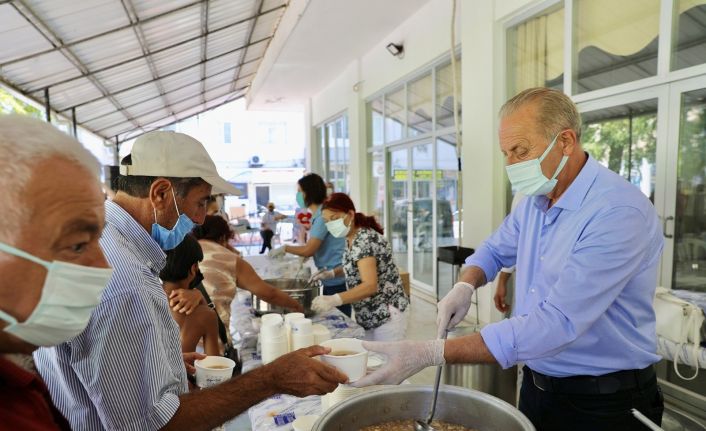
[159,235,222,356]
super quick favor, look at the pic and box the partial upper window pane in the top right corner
[672,0,706,70]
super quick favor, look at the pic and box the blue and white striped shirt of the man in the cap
[34,201,188,430]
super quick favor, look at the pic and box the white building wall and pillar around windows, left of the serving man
[311,0,546,322]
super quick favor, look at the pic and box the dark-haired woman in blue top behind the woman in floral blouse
[270,174,351,317]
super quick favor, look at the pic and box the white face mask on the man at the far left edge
[0,243,113,346]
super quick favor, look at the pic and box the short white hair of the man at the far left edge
[0,115,100,246]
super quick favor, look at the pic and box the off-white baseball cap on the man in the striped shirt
[120,131,240,196]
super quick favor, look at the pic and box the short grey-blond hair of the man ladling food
[500,87,581,141]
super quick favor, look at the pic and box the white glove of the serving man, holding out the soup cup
[352,340,446,388]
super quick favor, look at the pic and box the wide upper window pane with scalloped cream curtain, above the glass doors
[573,0,660,93]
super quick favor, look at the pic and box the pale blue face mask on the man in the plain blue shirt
[505,135,569,196]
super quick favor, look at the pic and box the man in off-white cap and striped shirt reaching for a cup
[35,131,346,430]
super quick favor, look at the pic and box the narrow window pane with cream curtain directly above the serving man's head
[507,7,564,96]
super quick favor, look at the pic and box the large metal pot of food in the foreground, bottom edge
[312,385,535,431]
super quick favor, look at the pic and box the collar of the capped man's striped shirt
[105,200,167,273]
